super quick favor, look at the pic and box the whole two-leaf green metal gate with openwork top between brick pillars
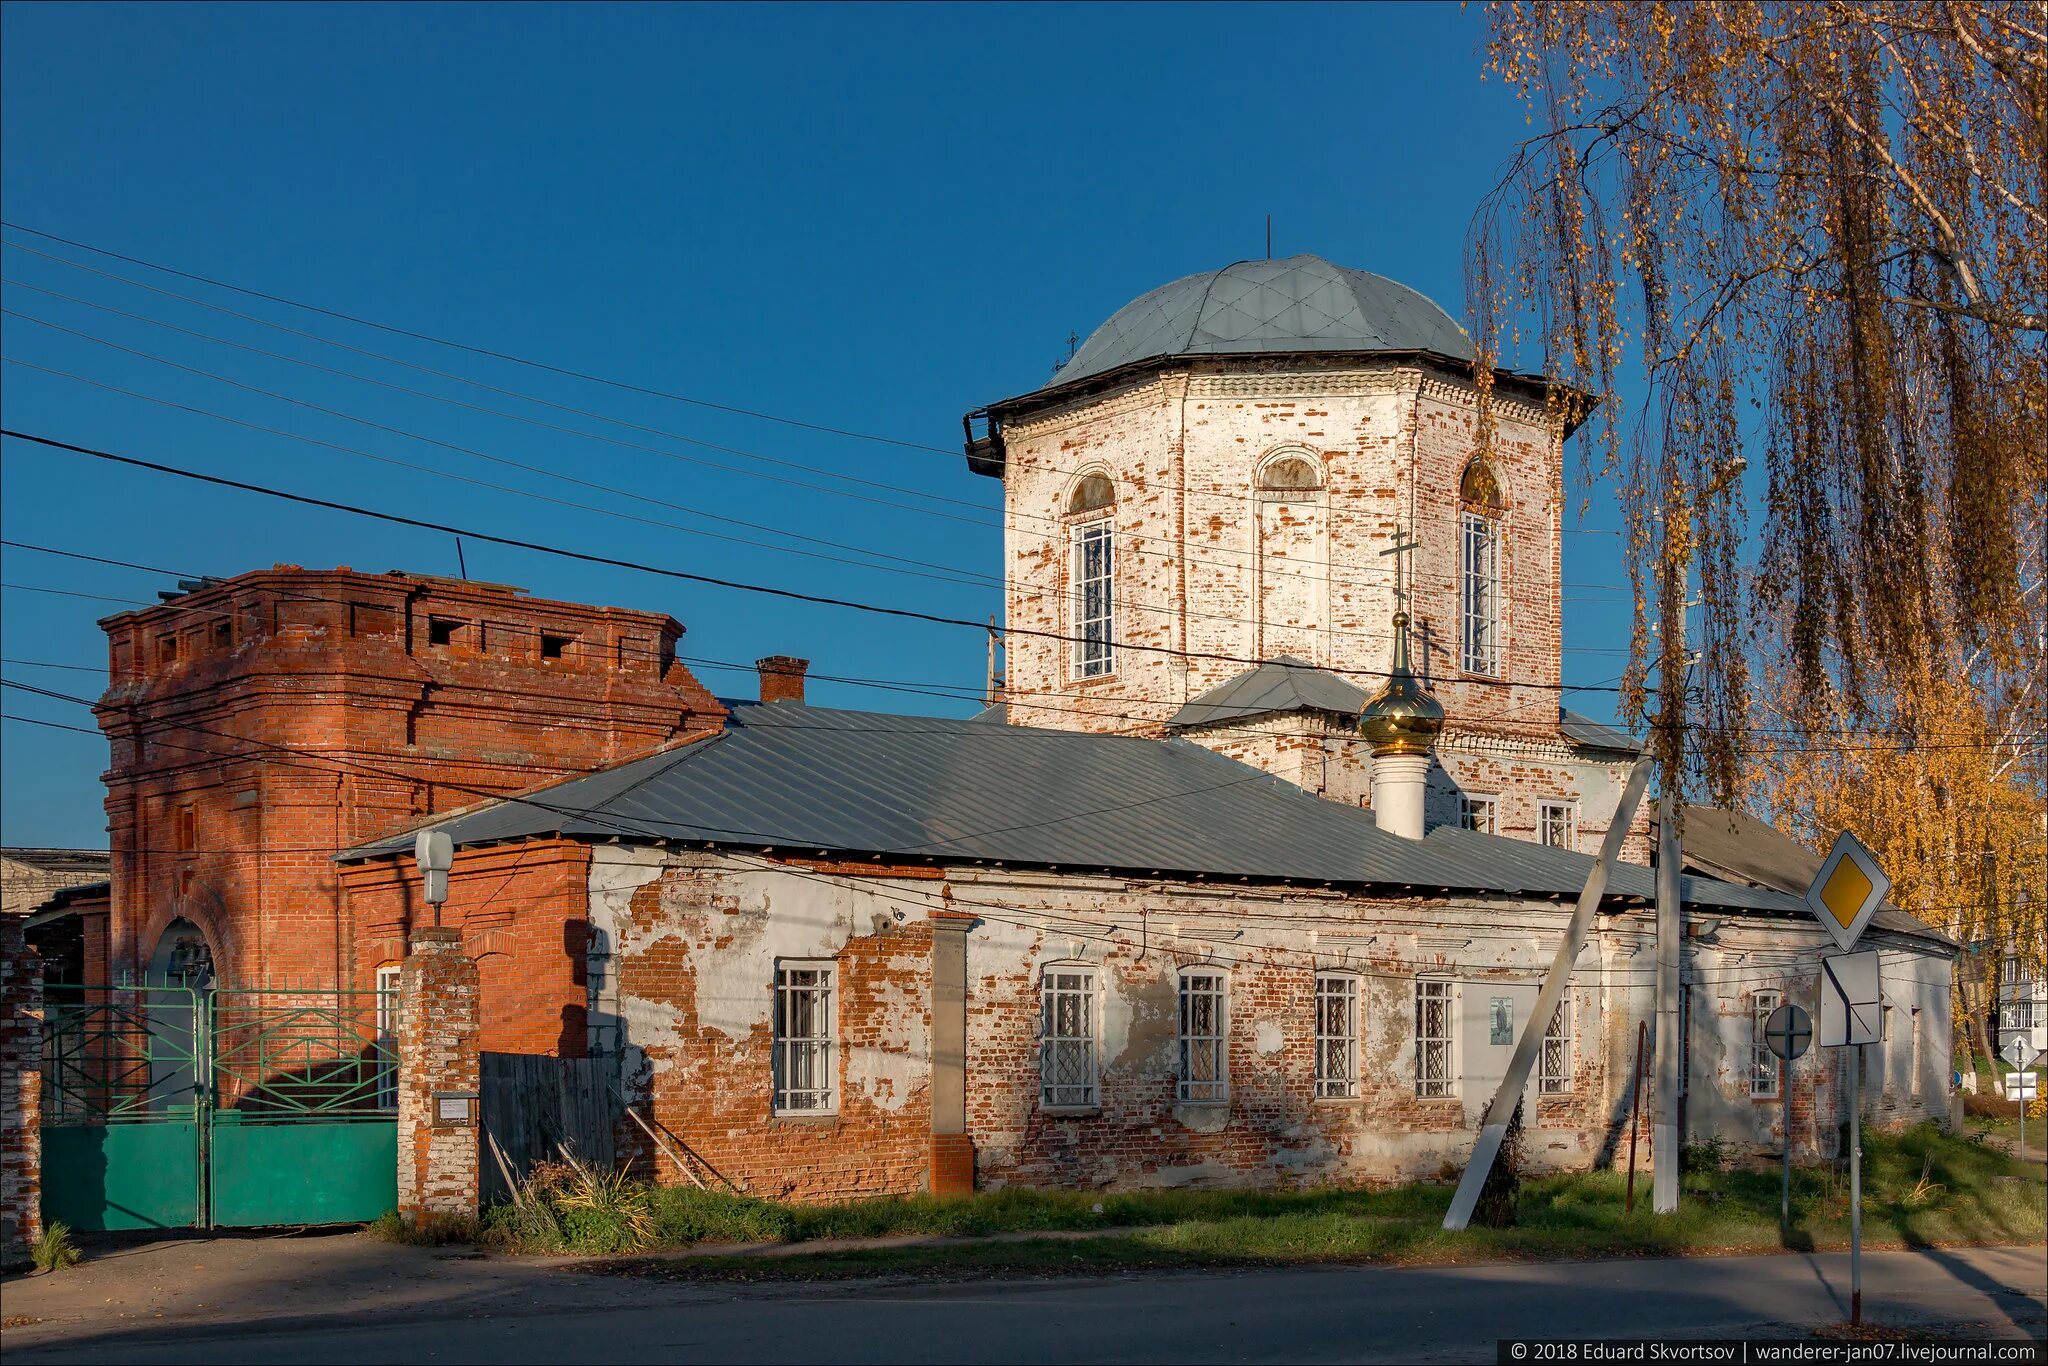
[43,987,397,1229]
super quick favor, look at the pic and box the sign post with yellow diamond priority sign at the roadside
[1788,829,1892,1325]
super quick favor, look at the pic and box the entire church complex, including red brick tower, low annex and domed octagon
[48,256,1956,1200]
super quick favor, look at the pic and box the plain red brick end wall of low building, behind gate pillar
[340,840,590,1057]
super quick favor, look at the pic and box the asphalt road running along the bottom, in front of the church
[4,1247,2048,1366]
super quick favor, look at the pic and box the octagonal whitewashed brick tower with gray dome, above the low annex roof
[969,256,1649,862]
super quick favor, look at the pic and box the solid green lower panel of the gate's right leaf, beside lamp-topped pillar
[207,1110,397,1229]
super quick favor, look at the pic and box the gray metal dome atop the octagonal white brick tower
[1049,256,1473,387]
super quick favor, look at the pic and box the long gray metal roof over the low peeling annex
[342,702,1826,913]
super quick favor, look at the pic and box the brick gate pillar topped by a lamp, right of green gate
[397,926,481,1225]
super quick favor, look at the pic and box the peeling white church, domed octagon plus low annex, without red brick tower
[360,256,1956,1198]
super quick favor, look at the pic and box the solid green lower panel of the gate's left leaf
[43,1122,199,1233]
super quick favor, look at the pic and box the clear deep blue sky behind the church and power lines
[0,4,1626,846]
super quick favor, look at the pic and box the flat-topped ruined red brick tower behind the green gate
[88,565,725,987]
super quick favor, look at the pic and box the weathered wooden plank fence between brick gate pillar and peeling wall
[477,1053,618,1202]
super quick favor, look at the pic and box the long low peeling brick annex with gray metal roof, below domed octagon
[344,679,1950,1198]
